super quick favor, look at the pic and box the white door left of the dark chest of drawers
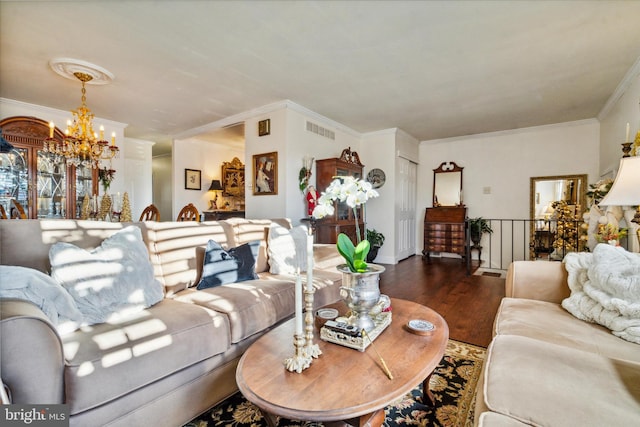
[395,157,418,261]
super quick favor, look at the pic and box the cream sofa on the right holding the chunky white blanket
[475,261,640,426]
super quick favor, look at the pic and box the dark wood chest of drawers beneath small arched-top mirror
[422,206,467,258]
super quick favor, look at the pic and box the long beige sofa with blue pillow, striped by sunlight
[0,218,341,427]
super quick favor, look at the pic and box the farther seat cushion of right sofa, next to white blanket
[494,298,640,362]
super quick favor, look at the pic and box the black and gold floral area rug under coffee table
[184,340,486,427]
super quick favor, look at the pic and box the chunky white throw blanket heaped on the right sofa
[562,244,640,344]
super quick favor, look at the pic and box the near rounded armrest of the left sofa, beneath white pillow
[0,299,65,404]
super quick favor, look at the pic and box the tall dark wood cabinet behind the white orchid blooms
[315,155,365,243]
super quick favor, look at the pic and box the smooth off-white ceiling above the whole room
[0,1,640,157]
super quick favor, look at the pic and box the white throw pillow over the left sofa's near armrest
[0,265,82,333]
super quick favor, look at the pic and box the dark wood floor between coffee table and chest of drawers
[380,256,505,347]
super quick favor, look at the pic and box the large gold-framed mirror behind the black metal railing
[529,174,587,259]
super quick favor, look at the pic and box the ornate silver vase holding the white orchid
[337,264,385,332]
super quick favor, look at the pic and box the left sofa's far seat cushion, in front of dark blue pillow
[174,279,295,344]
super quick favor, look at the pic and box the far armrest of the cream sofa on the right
[505,261,570,304]
